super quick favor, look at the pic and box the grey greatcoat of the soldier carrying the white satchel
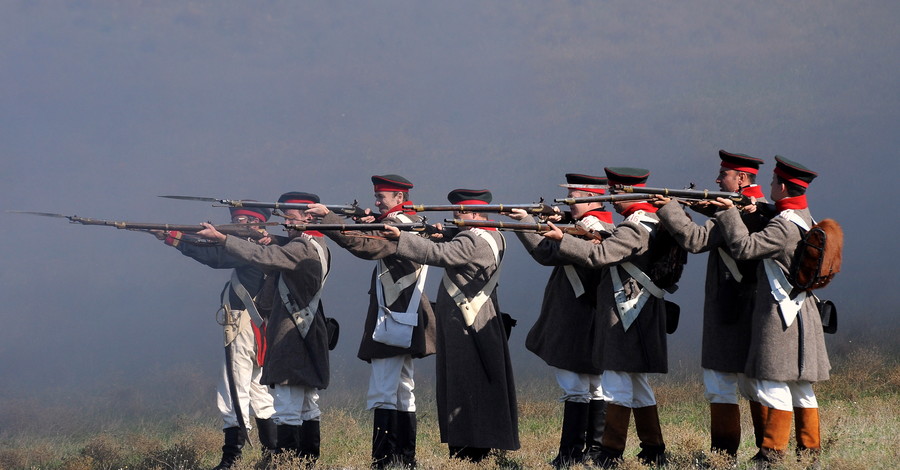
[322,213,435,362]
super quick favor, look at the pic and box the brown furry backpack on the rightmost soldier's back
[788,219,844,291]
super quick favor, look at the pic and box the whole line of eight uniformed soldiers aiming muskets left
[153,151,830,469]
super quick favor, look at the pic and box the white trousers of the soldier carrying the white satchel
[366,354,416,411]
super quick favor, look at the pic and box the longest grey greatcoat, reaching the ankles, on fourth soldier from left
[397,229,519,450]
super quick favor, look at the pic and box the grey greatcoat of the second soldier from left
[225,235,331,389]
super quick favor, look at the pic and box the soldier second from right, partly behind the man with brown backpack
[653,150,768,458]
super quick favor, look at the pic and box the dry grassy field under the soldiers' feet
[0,350,900,470]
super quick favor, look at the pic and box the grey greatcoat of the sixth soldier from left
[557,213,669,373]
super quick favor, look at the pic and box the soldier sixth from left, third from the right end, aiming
[544,167,668,467]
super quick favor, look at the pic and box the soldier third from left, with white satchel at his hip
[309,175,435,468]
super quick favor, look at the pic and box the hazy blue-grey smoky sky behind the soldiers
[0,0,900,406]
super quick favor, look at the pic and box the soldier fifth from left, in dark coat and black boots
[509,173,615,468]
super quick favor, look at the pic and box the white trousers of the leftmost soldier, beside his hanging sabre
[216,310,275,429]
